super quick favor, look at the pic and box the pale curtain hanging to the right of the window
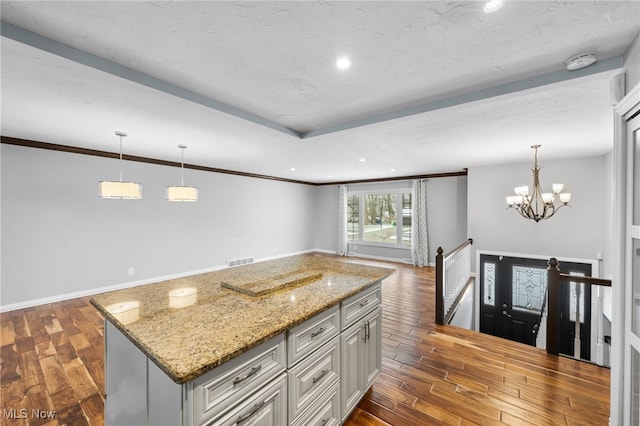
[411,179,429,266]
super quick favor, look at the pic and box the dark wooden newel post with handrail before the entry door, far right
[547,257,611,355]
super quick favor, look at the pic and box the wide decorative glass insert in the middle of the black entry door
[511,265,547,313]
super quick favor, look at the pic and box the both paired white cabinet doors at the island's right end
[340,306,382,420]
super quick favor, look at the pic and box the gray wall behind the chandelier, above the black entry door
[468,152,611,270]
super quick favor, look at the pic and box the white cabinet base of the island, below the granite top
[105,283,381,426]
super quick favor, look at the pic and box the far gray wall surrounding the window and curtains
[316,176,467,264]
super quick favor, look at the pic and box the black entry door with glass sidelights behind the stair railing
[479,254,591,358]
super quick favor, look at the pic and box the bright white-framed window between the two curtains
[347,192,411,246]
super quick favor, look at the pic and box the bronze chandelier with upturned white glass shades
[506,145,571,222]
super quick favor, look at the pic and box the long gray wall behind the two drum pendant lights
[0,144,316,307]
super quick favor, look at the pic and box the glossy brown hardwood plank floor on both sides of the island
[0,260,609,426]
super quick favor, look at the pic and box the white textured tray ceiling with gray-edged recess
[1,1,640,182]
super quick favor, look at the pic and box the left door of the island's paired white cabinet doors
[340,322,364,416]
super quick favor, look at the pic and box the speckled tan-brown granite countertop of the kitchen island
[91,253,395,384]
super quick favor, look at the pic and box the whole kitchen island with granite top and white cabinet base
[91,254,394,426]
